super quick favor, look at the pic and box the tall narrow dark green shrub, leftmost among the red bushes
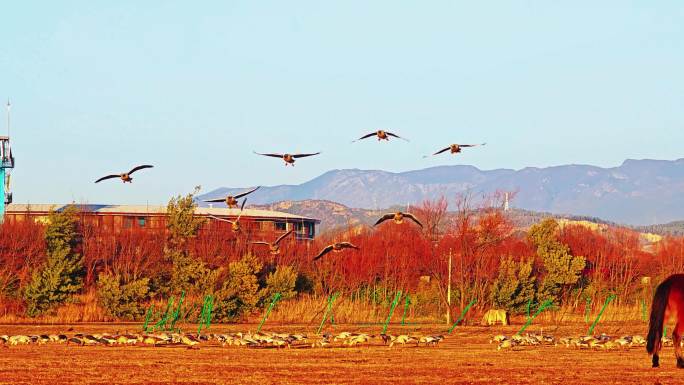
[24,208,84,317]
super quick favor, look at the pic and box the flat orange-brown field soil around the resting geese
[0,323,684,385]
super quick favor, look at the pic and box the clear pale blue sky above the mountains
[0,1,684,203]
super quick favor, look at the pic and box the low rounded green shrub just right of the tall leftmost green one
[97,274,150,321]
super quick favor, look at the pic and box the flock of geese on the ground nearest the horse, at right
[489,333,656,350]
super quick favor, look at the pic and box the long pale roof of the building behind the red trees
[5,203,320,223]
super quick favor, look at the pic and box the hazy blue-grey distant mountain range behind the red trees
[198,159,684,225]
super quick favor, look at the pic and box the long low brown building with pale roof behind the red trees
[5,204,320,240]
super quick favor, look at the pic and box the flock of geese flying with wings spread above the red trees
[95,130,486,261]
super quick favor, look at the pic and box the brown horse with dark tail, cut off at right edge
[646,274,684,368]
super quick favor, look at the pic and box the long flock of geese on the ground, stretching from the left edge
[0,332,444,349]
